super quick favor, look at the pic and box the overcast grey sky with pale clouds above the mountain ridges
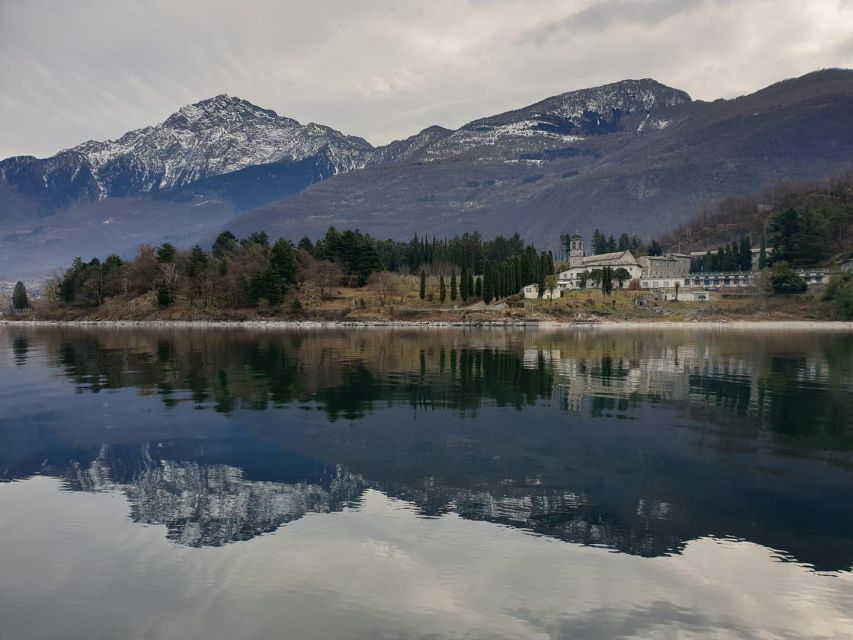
[5,0,853,157]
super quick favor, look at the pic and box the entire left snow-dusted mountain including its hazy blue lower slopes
[0,95,380,277]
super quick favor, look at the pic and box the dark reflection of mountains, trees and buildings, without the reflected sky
[0,327,853,570]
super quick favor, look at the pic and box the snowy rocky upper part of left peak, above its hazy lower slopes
[0,95,373,206]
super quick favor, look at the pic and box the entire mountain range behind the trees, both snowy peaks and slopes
[0,69,853,278]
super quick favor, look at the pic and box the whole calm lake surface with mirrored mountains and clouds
[0,327,853,640]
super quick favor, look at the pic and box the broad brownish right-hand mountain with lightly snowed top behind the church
[229,70,853,249]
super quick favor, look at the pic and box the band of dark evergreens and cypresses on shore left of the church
[50,227,555,311]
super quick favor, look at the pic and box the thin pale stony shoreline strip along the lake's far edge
[0,319,853,333]
